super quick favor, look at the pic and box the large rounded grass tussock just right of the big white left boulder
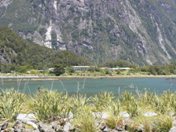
[30,90,71,120]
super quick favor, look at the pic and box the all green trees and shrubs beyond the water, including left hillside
[0,28,176,76]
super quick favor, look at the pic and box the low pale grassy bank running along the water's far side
[0,73,176,80]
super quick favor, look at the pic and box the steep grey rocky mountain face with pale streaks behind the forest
[0,0,176,65]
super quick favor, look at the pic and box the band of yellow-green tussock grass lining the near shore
[0,90,176,132]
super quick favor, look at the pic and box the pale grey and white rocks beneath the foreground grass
[0,112,176,132]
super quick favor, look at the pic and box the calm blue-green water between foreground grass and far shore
[0,78,176,95]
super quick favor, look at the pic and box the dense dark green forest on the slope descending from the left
[0,27,89,72]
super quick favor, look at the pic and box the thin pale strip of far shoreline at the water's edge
[0,75,176,80]
